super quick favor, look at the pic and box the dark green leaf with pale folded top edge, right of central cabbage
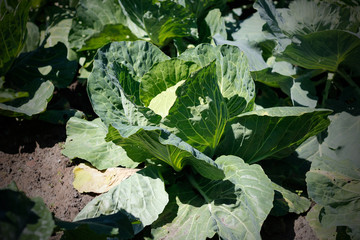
[217,107,331,163]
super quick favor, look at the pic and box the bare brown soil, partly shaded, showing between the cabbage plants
[0,87,317,240]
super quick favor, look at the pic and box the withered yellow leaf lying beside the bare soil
[73,163,139,193]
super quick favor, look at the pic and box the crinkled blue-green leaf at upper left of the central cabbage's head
[88,41,168,124]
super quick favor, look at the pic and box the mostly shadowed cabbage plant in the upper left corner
[0,0,82,123]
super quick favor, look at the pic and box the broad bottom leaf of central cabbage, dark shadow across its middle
[152,156,274,240]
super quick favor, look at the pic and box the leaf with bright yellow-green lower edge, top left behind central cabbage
[69,0,136,50]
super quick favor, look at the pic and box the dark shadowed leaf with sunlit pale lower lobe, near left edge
[0,40,77,116]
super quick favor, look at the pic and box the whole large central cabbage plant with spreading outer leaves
[63,41,331,239]
